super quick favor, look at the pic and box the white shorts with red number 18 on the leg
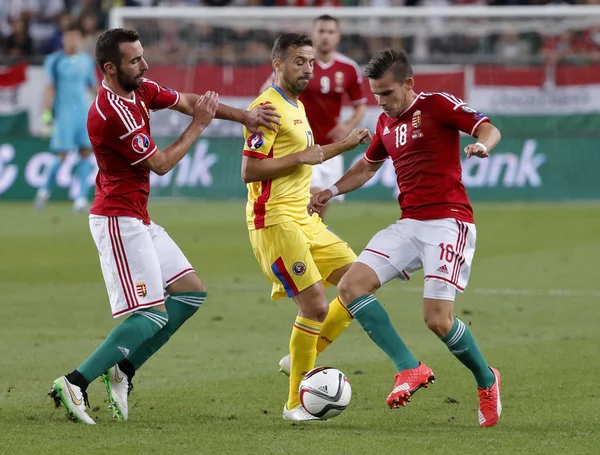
[357,218,477,292]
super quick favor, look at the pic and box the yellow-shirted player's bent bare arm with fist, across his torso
[242,145,323,183]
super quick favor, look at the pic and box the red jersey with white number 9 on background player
[269,52,367,145]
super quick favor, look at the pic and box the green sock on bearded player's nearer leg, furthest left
[76,309,169,383]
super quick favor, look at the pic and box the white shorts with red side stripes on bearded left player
[90,215,194,318]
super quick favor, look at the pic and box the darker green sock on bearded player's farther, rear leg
[125,292,206,371]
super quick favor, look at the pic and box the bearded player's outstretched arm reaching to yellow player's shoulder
[173,93,281,134]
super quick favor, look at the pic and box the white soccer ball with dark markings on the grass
[298,367,352,419]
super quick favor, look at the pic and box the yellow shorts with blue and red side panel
[249,214,356,300]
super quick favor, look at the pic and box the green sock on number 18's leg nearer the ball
[346,294,419,371]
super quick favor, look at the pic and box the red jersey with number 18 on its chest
[365,93,489,223]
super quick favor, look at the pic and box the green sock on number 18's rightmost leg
[441,318,495,389]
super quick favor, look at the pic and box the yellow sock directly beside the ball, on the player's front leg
[287,316,323,409]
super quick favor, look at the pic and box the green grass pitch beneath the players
[0,202,600,455]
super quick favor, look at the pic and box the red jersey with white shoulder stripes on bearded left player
[87,79,179,223]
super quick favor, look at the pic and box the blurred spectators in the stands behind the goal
[0,0,600,65]
